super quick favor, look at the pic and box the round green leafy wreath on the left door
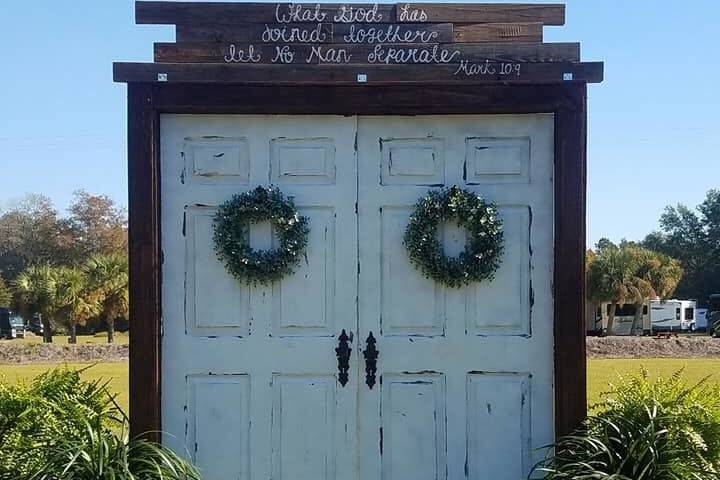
[213,187,310,285]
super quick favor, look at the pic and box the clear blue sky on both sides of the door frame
[0,0,720,248]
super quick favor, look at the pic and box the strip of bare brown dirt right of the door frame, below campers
[587,336,720,358]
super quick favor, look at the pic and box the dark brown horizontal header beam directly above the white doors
[154,83,580,115]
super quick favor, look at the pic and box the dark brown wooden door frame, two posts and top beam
[128,82,587,440]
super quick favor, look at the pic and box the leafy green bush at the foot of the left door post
[0,368,200,480]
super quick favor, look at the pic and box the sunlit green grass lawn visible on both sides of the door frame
[0,358,720,418]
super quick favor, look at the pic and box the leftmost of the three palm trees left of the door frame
[14,265,56,343]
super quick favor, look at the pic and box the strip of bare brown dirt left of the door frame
[0,340,129,364]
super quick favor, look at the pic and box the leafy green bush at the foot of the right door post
[536,370,720,480]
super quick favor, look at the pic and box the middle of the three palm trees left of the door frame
[53,267,100,343]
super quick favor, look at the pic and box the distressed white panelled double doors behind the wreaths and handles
[160,115,554,480]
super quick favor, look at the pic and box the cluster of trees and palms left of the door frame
[0,190,128,343]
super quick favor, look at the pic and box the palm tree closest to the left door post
[84,253,129,343]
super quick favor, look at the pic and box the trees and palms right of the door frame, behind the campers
[586,190,720,333]
